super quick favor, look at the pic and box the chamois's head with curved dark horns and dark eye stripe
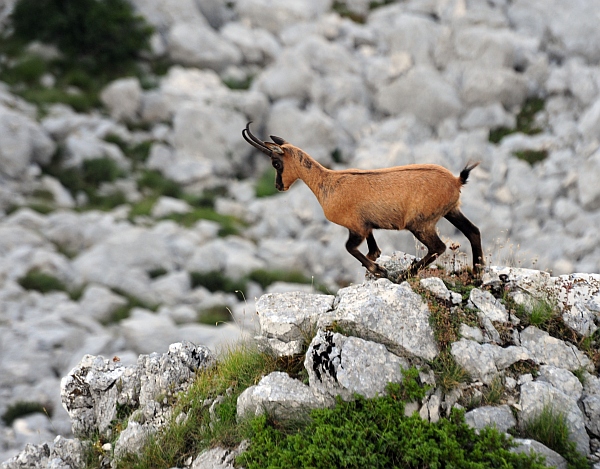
[242,122,304,191]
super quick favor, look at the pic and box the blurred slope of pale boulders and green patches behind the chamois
[0,0,600,461]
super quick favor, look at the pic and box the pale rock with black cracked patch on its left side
[304,330,409,400]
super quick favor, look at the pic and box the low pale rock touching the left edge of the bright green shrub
[237,371,333,420]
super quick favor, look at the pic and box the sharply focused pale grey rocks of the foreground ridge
[2,253,600,469]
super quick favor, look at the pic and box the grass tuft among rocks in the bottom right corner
[519,405,590,469]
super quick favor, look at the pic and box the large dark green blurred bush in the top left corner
[0,0,157,112]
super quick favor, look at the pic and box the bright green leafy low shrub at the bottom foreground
[237,369,545,469]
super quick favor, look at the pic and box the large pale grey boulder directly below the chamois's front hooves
[318,279,438,360]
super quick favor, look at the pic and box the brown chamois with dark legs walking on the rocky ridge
[242,122,484,277]
